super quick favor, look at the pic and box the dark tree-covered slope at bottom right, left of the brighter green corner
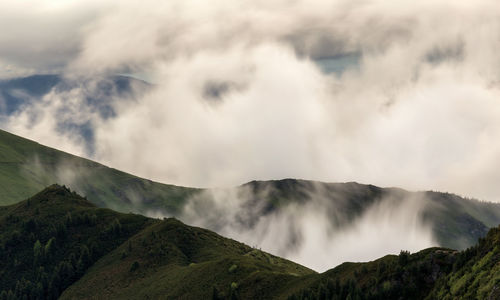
[288,248,457,299]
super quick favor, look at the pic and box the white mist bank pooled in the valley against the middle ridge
[180,184,437,272]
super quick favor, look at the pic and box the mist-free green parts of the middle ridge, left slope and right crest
[0,131,500,249]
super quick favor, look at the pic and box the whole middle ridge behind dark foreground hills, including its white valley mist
[0,124,500,271]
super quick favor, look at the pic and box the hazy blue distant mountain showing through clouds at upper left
[0,75,151,153]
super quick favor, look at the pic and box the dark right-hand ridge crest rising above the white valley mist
[235,179,500,249]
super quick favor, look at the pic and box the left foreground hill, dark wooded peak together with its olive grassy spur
[0,185,314,299]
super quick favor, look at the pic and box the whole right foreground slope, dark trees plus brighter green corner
[289,227,500,299]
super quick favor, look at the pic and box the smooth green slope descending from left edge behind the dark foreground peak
[0,130,197,213]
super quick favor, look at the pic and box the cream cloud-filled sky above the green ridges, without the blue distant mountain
[0,0,500,202]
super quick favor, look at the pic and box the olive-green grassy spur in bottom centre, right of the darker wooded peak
[62,219,313,299]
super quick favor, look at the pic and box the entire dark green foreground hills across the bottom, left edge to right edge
[0,185,500,300]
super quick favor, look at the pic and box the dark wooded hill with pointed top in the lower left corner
[0,185,152,299]
